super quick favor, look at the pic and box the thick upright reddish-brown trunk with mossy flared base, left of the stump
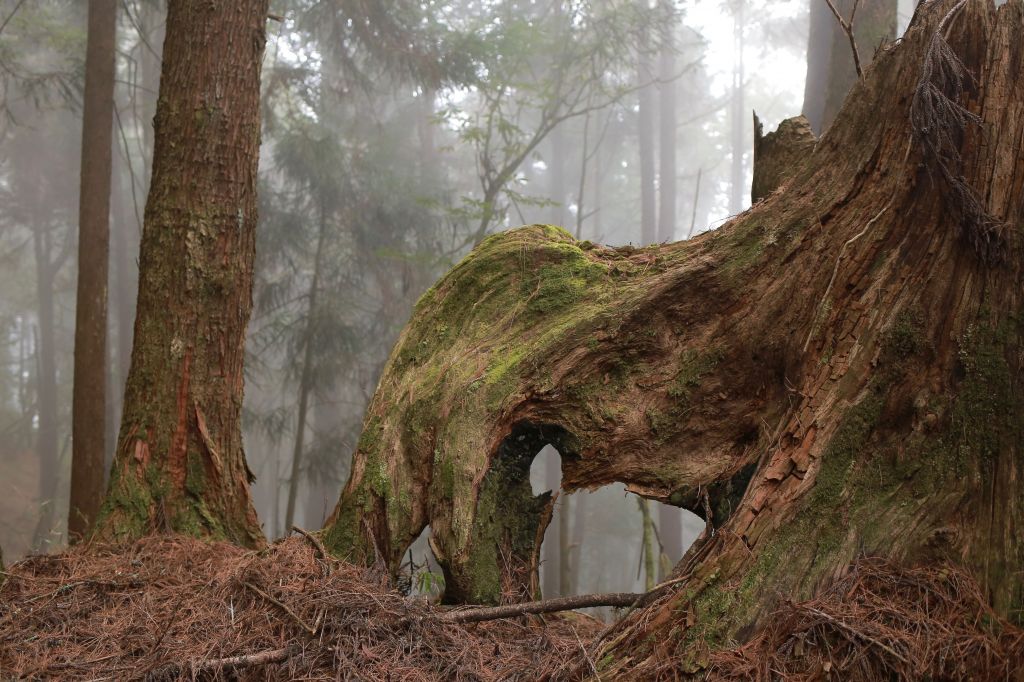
[96,0,267,546]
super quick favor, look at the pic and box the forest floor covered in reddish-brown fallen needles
[0,536,1024,682]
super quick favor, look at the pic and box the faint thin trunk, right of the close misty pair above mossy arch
[657,5,678,242]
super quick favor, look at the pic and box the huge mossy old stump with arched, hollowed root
[325,0,1024,659]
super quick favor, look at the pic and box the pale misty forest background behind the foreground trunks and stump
[0,0,912,596]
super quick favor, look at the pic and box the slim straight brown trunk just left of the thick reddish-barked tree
[68,0,117,541]
